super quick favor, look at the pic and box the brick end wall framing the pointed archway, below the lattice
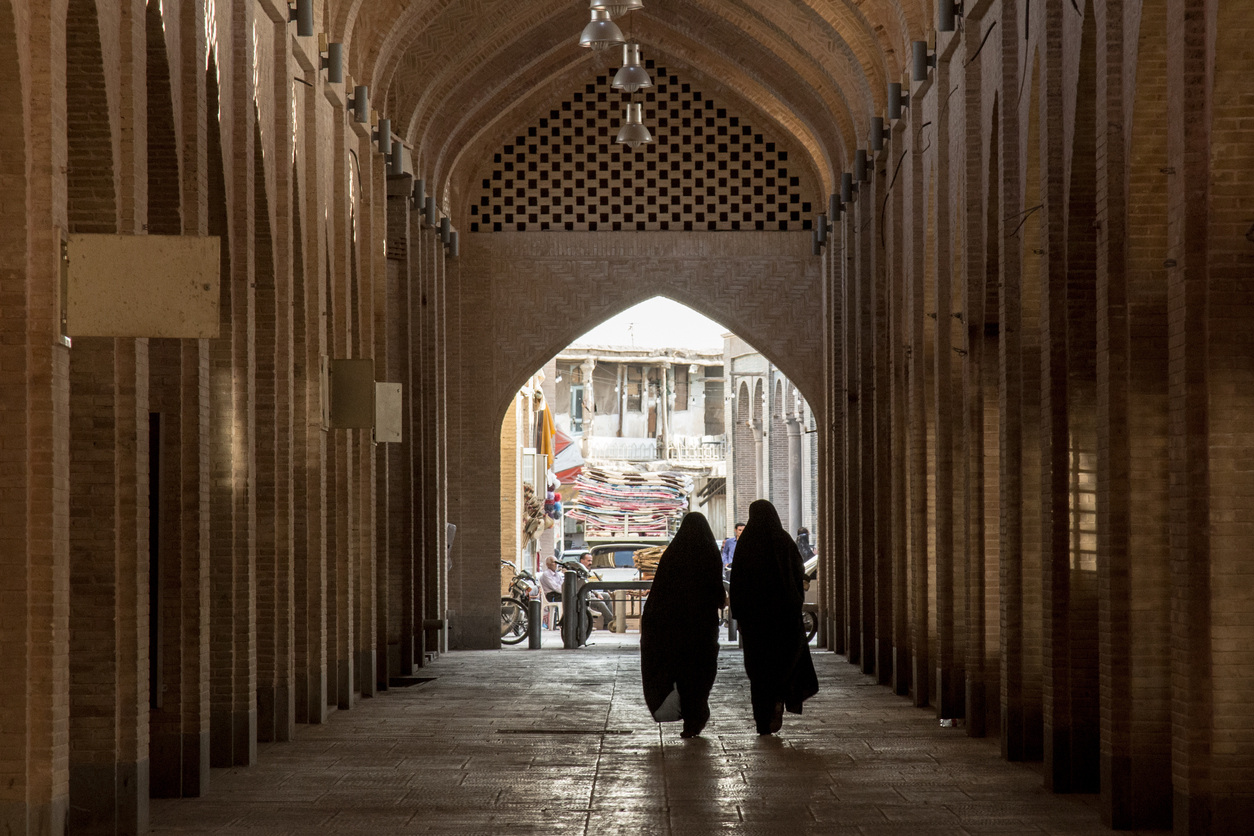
[446,232,823,648]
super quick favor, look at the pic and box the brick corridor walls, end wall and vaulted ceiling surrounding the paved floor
[0,0,1254,835]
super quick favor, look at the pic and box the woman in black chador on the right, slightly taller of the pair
[731,499,819,734]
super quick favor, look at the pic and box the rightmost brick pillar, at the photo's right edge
[1165,0,1254,835]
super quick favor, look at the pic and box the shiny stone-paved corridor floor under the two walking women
[152,632,1148,836]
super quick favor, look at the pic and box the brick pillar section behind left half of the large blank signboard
[65,5,148,833]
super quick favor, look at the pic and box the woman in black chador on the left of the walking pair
[640,513,724,737]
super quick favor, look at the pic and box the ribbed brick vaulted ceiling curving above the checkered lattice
[324,0,933,209]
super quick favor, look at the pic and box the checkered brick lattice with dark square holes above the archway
[470,61,818,232]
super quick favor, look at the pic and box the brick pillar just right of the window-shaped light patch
[1097,0,1171,828]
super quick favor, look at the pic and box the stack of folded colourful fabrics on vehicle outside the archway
[567,466,692,540]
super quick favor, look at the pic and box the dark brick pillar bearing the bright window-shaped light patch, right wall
[1025,0,1097,792]
